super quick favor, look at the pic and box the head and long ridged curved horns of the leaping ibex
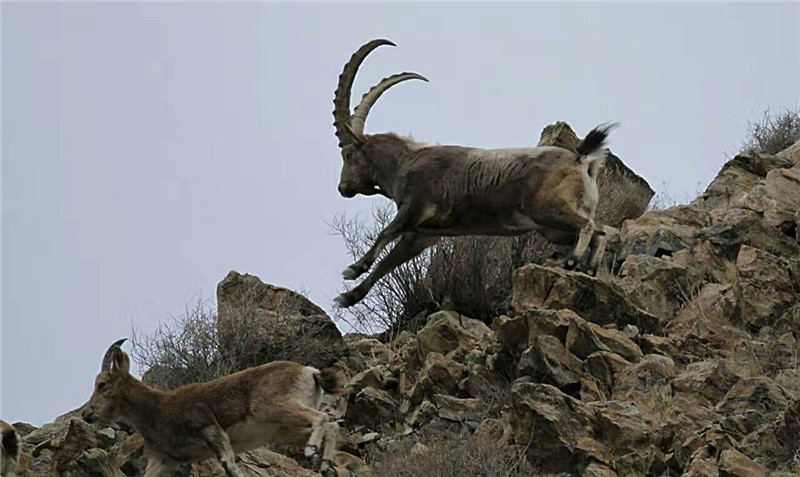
[333,40,428,198]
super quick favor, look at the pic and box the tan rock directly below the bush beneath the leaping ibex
[417,311,492,357]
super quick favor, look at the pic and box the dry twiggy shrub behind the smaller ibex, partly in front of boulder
[131,300,336,390]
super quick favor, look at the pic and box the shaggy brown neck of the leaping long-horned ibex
[365,133,420,198]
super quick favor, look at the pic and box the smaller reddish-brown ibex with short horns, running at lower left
[83,339,340,477]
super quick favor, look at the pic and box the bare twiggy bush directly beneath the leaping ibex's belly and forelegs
[331,203,553,335]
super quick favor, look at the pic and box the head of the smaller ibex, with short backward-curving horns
[82,338,130,423]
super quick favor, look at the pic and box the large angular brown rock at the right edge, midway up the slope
[734,246,800,330]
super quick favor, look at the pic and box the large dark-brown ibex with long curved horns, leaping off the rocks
[333,40,615,307]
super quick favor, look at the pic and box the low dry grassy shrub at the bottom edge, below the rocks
[371,424,537,477]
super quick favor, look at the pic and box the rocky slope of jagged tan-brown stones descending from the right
[7,139,800,477]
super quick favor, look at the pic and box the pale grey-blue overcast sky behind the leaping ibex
[0,3,800,425]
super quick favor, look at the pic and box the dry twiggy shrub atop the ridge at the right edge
[742,109,800,154]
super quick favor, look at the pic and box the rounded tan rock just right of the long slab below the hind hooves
[618,255,690,316]
